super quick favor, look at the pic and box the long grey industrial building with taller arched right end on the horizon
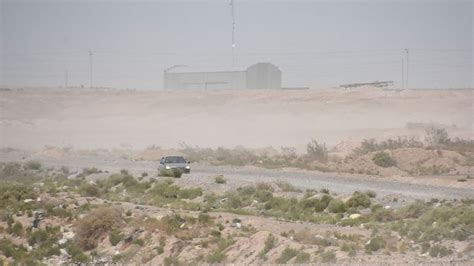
[163,63,281,90]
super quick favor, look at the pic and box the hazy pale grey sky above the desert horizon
[0,0,474,89]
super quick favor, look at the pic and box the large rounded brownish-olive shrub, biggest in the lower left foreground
[75,207,122,250]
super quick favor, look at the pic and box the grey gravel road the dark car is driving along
[0,149,474,199]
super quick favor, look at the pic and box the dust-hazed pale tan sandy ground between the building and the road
[0,88,474,150]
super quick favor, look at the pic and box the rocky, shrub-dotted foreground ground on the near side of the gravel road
[0,158,474,265]
